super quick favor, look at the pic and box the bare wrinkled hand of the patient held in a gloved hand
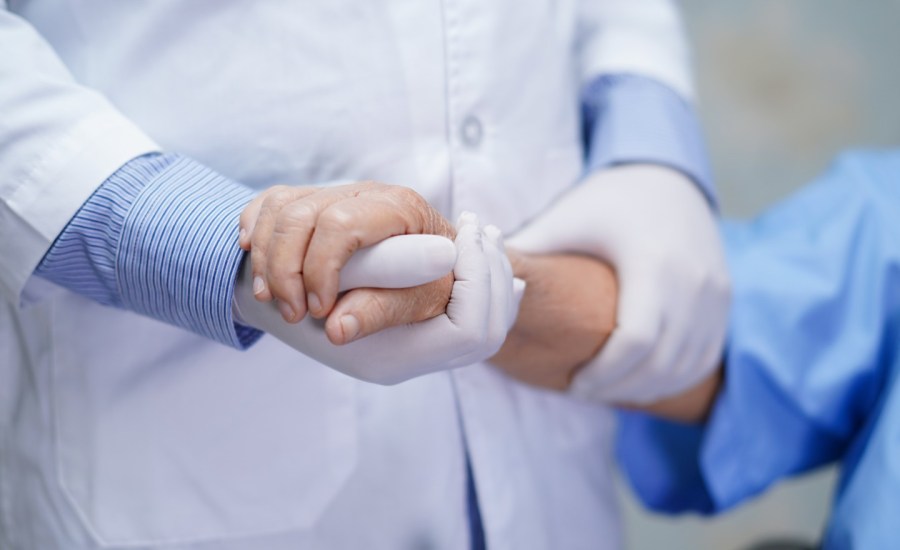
[240,182,455,344]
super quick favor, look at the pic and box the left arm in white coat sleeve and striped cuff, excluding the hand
[0,5,272,347]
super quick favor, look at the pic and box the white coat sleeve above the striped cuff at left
[0,5,158,304]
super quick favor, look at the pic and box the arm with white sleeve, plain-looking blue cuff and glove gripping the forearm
[492,1,728,403]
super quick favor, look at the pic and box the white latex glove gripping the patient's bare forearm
[507,165,730,404]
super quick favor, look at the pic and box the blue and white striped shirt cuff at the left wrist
[35,154,262,349]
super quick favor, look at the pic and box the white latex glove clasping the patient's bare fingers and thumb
[234,214,524,384]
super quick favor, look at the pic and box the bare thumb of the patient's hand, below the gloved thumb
[325,274,453,345]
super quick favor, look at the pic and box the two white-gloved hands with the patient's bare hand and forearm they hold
[229,165,729,414]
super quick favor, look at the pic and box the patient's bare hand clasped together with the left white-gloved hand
[234,182,523,384]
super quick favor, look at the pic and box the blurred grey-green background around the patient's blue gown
[622,0,900,550]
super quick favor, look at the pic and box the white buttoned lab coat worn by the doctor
[0,0,689,550]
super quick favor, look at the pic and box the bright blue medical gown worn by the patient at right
[617,152,900,550]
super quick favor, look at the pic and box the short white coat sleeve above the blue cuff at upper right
[576,0,694,100]
